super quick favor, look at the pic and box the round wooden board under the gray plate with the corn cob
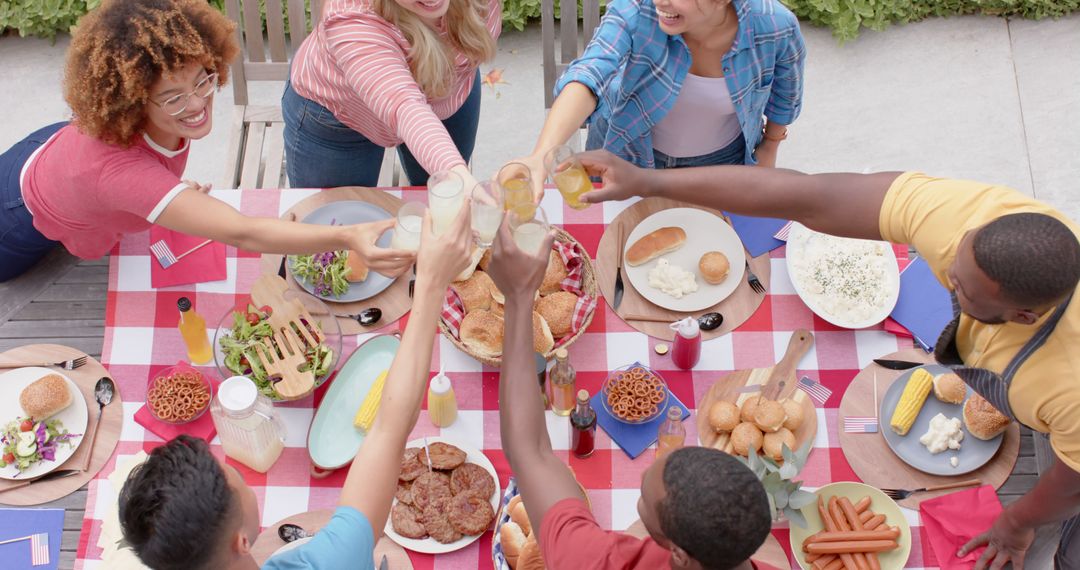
[836,349,1020,508]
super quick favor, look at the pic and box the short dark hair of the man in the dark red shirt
[658,447,772,570]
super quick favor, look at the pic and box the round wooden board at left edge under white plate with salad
[0,344,124,506]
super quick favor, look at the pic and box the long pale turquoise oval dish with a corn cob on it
[308,335,401,470]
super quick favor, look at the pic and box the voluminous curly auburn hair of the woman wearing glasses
[64,0,240,146]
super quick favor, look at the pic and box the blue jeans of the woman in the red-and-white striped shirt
[281,70,481,188]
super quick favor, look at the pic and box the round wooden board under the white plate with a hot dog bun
[596,198,771,340]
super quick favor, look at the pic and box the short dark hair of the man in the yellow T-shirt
[972,213,1080,309]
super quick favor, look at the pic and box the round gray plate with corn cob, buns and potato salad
[878,364,1004,476]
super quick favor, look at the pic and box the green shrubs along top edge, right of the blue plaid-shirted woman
[781,0,1080,43]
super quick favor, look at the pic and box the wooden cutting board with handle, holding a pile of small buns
[697,329,818,451]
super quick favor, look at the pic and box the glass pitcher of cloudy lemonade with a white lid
[210,376,285,473]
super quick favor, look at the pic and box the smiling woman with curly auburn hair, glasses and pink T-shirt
[0,0,414,282]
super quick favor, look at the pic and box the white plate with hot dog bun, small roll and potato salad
[623,208,746,313]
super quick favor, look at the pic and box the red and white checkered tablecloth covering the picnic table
[76,189,936,570]
